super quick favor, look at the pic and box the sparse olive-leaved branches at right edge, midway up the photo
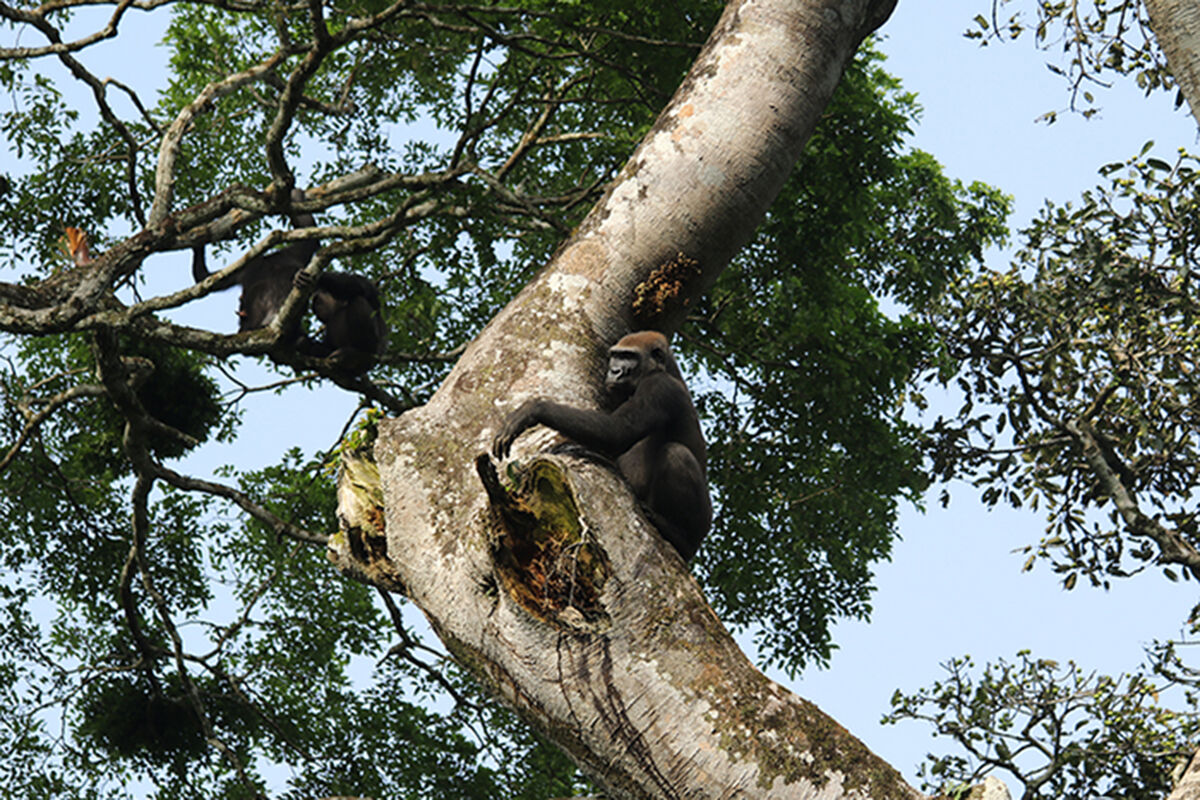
[930,150,1200,588]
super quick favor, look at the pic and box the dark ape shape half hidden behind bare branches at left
[192,190,388,375]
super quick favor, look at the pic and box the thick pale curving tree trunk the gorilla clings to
[331,0,920,799]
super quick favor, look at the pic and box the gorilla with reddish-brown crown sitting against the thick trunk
[492,331,713,561]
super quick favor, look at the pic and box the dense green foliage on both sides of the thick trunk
[0,0,1007,798]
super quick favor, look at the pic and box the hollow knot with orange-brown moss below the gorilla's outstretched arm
[475,456,610,630]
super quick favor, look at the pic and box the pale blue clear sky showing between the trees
[9,0,1196,789]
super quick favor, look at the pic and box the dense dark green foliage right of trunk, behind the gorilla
[683,47,1008,673]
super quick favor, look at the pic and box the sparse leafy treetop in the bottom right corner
[884,651,1200,800]
